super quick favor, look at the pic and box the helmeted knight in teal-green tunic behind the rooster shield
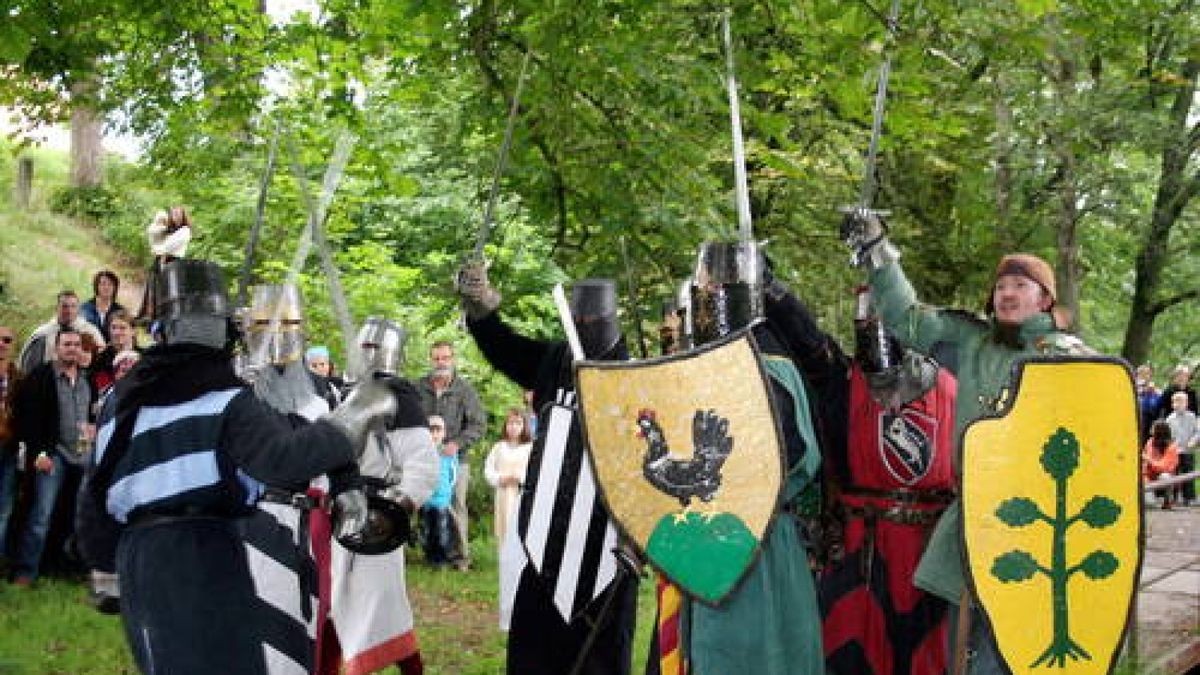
[657,241,824,675]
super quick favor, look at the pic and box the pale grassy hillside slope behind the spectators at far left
[0,204,145,342]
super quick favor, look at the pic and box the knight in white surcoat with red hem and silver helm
[314,317,438,675]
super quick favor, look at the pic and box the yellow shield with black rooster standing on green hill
[576,331,784,604]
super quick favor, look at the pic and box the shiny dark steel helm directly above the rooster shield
[689,241,762,345]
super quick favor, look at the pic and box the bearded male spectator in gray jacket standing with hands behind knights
[416,340,487,571]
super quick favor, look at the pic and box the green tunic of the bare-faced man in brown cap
[870,263,1086,604]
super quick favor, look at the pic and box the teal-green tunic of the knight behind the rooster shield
[683,357,824,675]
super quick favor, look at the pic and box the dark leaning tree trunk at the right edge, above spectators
[1121,59,1200,364]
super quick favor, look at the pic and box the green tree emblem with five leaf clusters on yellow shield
[991,426,1121,668]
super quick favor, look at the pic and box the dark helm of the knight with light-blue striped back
[155,258,230,350]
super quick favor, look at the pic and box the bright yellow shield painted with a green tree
[961,357,1142,675]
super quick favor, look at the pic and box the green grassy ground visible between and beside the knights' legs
[0,540,654,675]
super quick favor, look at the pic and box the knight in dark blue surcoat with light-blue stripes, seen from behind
[79,258,401,674]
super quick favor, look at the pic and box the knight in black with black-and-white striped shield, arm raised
[458,263,637,675]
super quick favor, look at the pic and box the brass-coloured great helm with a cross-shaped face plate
[242,283,305,365]
